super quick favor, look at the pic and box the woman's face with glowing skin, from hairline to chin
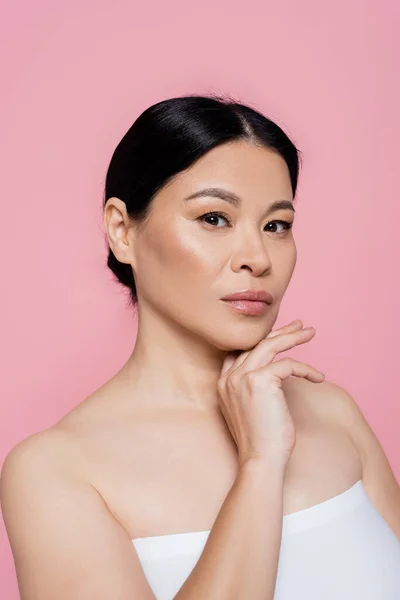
[115,141,297,350]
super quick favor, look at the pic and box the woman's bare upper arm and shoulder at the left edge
[0,430,154,600]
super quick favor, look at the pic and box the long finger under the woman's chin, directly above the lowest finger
[231,327,315,373]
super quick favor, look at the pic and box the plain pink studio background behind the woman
[0,0,400,600]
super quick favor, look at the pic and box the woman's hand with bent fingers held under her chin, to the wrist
[217,321,325,467]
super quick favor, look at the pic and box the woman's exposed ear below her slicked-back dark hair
[103,197,135,269]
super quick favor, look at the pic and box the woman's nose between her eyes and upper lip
[231,230,271,276]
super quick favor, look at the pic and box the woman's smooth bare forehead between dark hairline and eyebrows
[166,141,293,202]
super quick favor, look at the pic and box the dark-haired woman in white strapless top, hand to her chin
[1,96,400,600]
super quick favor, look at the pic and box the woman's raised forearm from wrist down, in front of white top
[175,461,284,600]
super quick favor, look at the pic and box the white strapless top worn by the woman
[132,479,400,600]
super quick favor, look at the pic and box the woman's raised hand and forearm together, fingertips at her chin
[175,324,324,600]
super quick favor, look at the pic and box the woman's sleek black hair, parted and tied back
[103,94,301,306]
